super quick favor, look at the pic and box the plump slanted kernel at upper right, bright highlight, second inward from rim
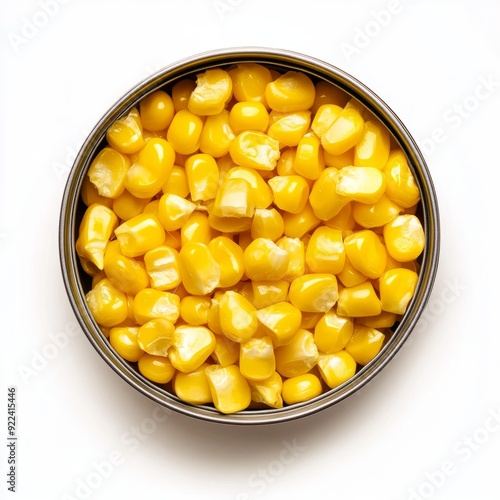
[321,106,365,155]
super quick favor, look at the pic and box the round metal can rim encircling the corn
[59,47,440,425]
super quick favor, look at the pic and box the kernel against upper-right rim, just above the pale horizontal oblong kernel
[354,120,391,170]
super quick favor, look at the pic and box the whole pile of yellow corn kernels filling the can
[76,63,424,414]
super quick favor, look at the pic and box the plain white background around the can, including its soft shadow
[0,0,500,500]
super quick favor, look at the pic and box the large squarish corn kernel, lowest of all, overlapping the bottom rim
[205,365,251,414]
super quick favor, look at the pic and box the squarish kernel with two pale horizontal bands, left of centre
[144,246,181,290]
